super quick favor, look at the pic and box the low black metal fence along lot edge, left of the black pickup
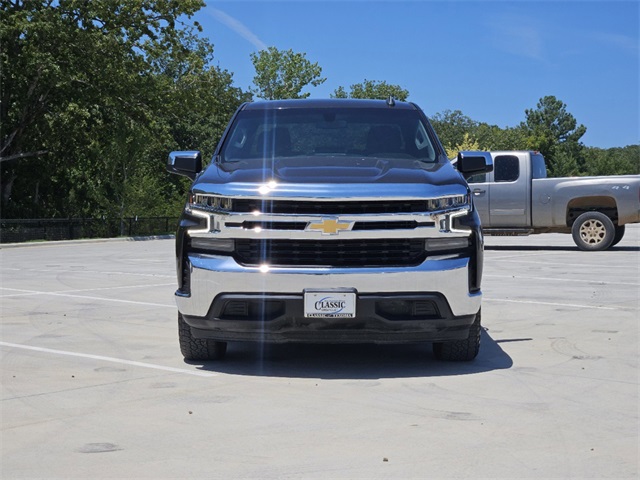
[0,217,178,243]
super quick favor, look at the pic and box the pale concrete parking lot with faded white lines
[0,225,640,479]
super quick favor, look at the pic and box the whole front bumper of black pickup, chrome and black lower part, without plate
[176,253,482,343]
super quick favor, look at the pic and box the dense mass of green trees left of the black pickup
[0,0,247,221]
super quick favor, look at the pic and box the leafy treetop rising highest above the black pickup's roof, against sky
[251,47,327,100]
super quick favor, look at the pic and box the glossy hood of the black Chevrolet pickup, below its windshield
[193,156,467,198]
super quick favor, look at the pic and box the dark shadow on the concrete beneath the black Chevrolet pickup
[188,331,513,379]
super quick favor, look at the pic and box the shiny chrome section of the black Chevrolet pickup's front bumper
[176,254,482,317]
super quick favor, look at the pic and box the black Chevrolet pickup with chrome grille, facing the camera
[167,99,492,360]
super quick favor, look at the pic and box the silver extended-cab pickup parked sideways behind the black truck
[468,151,640,251]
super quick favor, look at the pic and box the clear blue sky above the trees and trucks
[188,0,640,148]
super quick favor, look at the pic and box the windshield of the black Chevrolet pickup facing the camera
[220,108,436,162]
